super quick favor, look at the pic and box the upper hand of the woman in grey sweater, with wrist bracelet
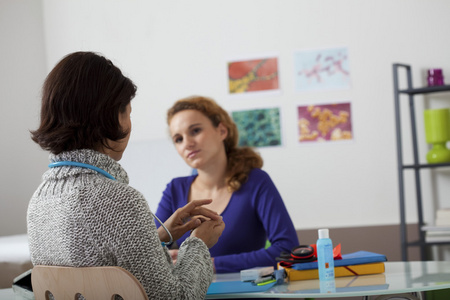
[158,199,222,242]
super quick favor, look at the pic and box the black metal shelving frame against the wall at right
[393,63,450,261]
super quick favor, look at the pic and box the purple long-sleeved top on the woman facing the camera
[156,169,299,273]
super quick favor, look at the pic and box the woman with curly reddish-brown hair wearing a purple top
[156,96,298,273]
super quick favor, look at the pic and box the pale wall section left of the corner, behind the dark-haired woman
[0,0,48,235]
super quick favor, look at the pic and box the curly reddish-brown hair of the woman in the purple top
[167,96,263,192]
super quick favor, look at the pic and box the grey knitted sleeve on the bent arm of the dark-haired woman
[79,182,213,299]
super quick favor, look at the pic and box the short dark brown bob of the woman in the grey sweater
[31,52,137,154]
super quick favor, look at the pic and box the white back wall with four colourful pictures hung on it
[1,0,450,234]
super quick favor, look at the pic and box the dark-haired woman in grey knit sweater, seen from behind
[27,52,224,299]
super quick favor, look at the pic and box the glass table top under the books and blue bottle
[206,261,450,299]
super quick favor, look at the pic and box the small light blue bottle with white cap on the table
[316,229,334,281]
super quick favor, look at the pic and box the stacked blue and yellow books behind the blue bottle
[278,251,387,280]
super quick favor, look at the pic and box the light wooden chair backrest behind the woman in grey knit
[31,265,148,300]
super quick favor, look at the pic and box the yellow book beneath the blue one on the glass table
[278,262,384,280]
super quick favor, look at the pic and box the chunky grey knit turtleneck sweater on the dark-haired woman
[27,149,213,299]
